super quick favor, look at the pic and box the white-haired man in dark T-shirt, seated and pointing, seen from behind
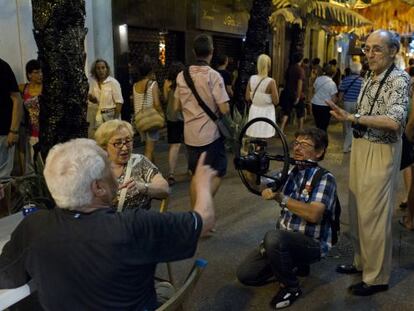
[0,139,215,310]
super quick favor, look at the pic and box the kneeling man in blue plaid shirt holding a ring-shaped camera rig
[237,128,337,309]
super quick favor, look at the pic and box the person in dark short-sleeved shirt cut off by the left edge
[0,58,23,181]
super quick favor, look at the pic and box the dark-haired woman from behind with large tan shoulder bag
[133,61,165,162]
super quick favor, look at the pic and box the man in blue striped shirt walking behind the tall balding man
[338,61,363,153]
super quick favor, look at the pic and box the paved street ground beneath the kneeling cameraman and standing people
[150,122,414,311]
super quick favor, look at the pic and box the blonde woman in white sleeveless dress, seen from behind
[245,54,279,138]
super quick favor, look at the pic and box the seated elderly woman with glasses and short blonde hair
[95,120,169,210]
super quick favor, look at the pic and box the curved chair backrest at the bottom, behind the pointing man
[156,259,207,311]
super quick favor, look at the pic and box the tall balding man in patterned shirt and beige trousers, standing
[327,30,409,296]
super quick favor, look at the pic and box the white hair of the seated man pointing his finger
[43,138,108,209]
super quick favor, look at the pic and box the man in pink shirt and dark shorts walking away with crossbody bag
[175,34,229,204]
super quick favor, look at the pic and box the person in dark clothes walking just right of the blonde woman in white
[280,53,305,131]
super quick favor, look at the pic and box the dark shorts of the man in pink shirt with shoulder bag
[186,137,227,177]
